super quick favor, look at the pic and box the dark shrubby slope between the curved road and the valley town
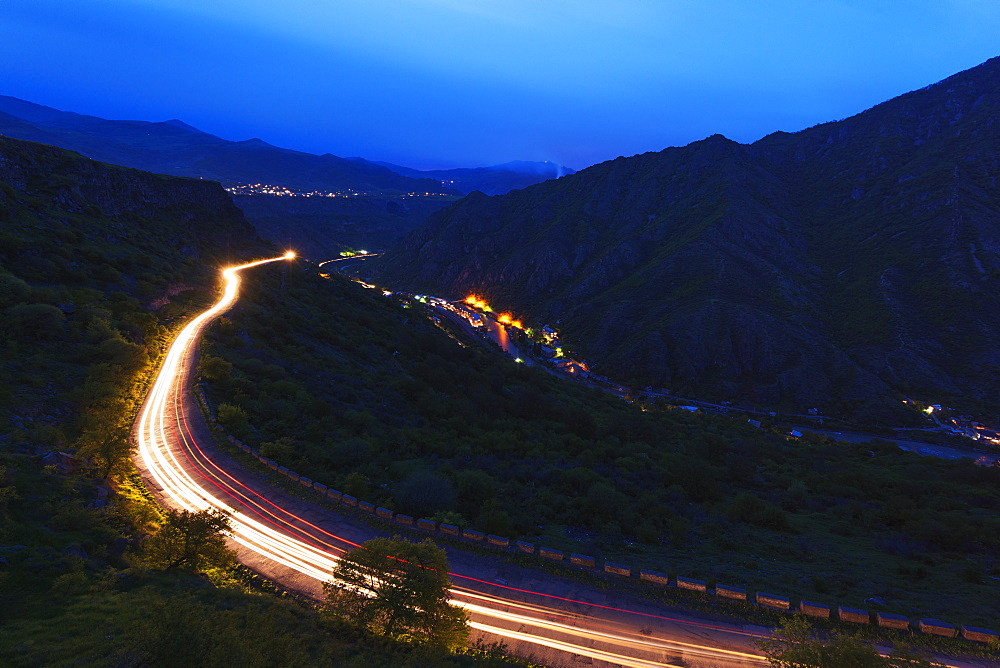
[197,270,1000,625]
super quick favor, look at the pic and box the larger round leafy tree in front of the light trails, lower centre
[323,536,469,648]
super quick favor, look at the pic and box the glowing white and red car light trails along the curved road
[135,252,764,668]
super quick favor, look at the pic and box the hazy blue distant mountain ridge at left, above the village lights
[0,96,448,195]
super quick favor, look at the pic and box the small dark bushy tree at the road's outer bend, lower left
[146,509,236,572]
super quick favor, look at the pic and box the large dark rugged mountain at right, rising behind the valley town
[374,58,1000,420]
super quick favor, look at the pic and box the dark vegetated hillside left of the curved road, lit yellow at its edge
[0,137,507,667]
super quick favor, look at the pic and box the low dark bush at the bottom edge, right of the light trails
[757,617,944,668]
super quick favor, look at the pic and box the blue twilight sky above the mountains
[0,0,1000,169]
